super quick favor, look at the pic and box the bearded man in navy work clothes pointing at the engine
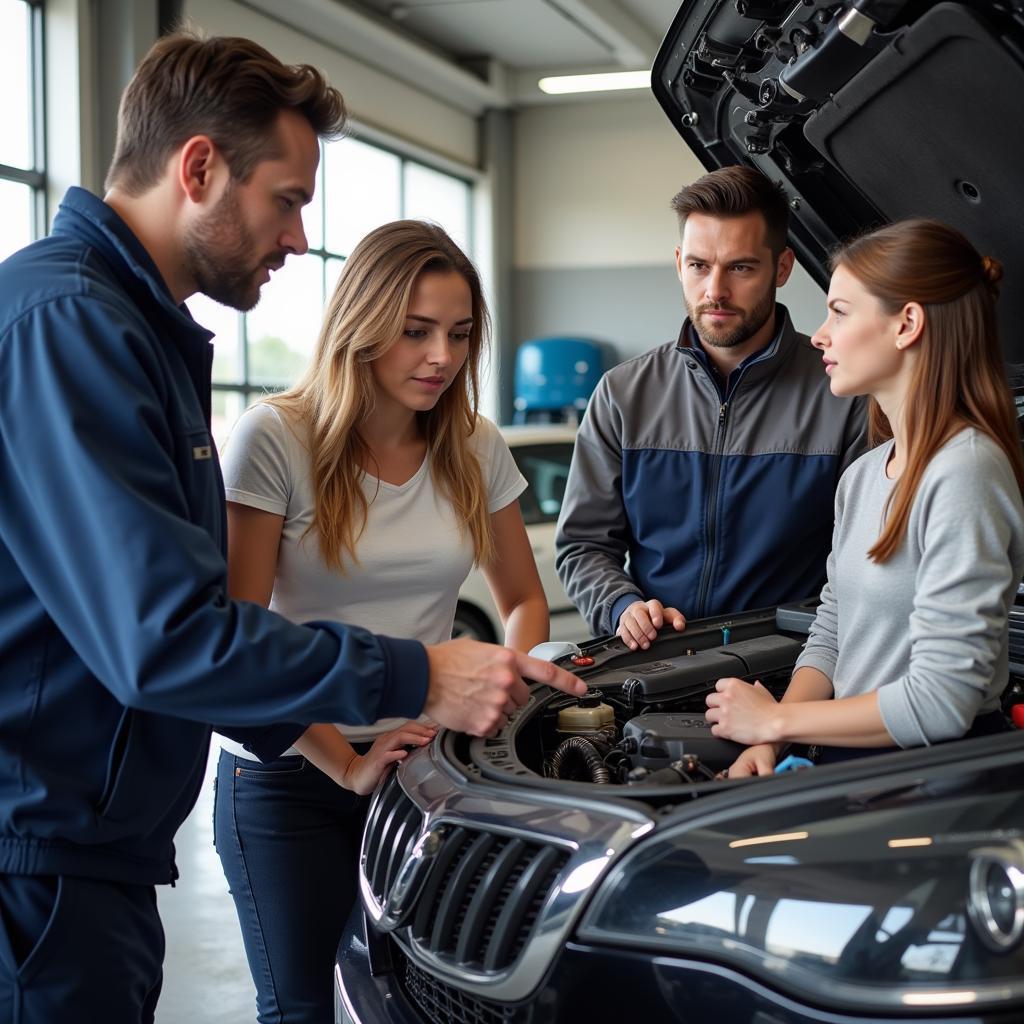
[0,28,585,1024]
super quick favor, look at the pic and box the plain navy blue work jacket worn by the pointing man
[0,188,428,884]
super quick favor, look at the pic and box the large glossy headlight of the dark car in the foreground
[579,785,1024,1013]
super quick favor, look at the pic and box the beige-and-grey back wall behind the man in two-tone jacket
[503,93,824,416]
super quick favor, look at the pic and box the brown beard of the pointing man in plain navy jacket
[183,184,270,312]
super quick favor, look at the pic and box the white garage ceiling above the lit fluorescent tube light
[242,0,680,114]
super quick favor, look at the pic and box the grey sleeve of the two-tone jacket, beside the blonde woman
[555,376,643,635]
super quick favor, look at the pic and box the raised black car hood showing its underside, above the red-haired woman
[651,0,1024,368]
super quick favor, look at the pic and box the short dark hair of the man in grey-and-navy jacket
[672,167,790,259]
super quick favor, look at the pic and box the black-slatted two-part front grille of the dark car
[362,777,569,974]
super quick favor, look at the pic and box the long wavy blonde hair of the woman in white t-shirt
[264,220,495,572]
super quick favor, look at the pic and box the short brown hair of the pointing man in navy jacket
[106,31,346,196]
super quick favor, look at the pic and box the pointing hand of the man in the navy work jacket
[423,639,587,736]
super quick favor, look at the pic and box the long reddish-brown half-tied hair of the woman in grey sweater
[831,220,1024,562]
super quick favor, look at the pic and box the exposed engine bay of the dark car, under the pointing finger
[462,602,813,792]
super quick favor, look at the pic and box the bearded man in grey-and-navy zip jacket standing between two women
[555,167,864,649]
